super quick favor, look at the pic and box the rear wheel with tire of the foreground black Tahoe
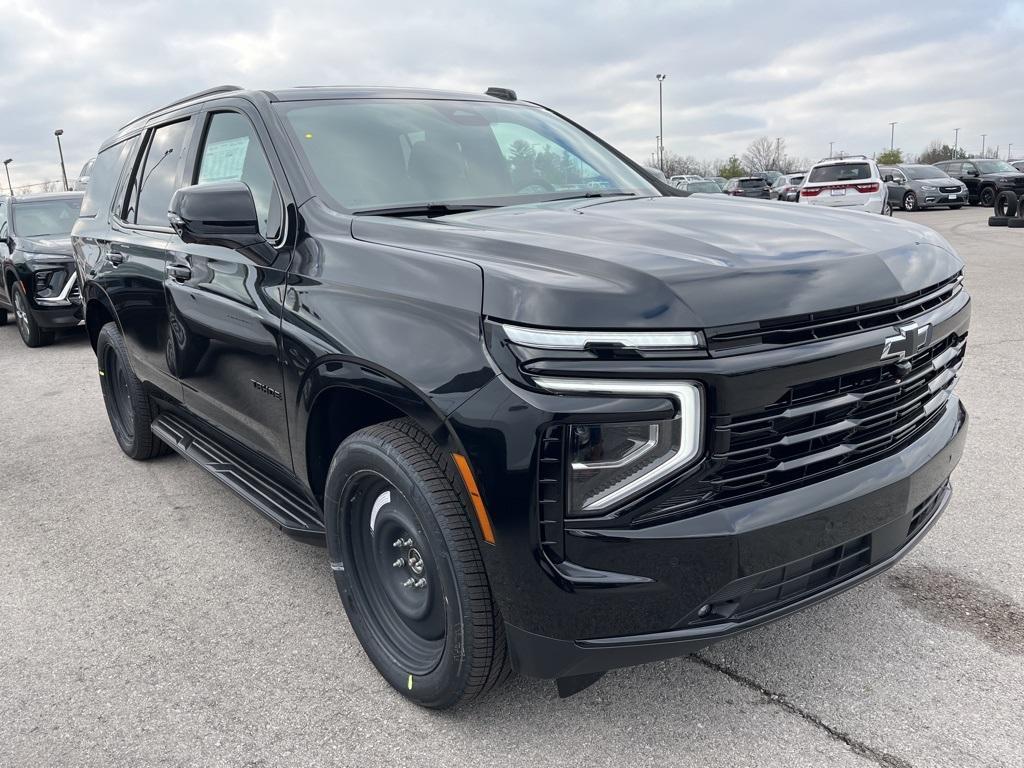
[96,323,168,461]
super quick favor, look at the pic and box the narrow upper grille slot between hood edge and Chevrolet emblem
[707,273,964,352]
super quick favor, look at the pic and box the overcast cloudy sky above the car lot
[0,0,1024,185]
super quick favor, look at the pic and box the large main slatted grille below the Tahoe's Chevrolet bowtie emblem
[632,334,967,524]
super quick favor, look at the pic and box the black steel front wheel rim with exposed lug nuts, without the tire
[342,471,446,675]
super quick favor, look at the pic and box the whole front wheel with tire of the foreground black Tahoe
[325,419,511,709]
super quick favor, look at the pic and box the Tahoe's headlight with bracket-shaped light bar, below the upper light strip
[535,377,703,517]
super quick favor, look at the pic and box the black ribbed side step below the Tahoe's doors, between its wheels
[152,413,326,544]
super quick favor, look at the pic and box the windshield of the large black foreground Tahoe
[276,99,658,212]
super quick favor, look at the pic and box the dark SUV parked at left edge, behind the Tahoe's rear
[0,193,82,347]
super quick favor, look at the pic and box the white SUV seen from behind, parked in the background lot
[798,155,892,213]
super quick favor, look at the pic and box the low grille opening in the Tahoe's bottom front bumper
[687,480,949,625]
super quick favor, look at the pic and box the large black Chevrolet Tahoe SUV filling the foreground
[74,87,970,708]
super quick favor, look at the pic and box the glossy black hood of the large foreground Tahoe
[352,195,963,329]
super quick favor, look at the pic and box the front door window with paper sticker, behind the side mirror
[196,112,282,240]
